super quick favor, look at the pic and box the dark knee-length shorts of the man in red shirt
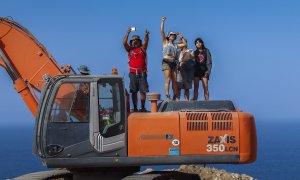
[129,73,149,93]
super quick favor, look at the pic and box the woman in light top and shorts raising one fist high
[160,17,186,100]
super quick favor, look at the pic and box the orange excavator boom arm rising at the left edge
[0,17,68,116]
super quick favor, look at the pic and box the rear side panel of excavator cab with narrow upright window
[90,77,127,152]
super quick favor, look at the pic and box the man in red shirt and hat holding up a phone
[123,28,149,112]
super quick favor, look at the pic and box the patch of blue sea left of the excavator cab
[0,125,46,180]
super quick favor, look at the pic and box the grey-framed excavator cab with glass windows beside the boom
[35,75,127,167]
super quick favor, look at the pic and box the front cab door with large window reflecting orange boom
[35,76,93,157]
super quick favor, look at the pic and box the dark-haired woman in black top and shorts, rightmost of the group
[193,38,212,101]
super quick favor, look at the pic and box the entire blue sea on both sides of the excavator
[0,121,300,180]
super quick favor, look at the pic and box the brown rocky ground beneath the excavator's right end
[139,165,254,180]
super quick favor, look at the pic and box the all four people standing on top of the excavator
[123,17,212,112]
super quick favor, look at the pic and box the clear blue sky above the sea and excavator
[0,0,300,125]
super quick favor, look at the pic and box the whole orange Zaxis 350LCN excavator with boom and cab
[0,17,257,179]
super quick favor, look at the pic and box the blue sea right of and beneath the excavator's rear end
[144,121,300,180]
